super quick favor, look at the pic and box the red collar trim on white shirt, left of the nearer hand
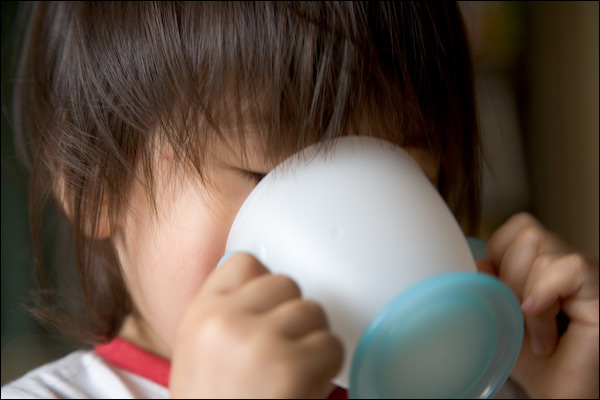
[94,338,171,387]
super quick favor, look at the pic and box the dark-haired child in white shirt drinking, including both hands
[2,1,598,398]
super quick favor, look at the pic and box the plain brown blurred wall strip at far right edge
[525,2,599,258]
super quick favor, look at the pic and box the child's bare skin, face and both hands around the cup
[112,133,598,398]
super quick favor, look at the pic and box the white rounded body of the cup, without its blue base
[226,136,476,387]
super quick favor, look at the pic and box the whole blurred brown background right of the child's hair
[459,1,599,258]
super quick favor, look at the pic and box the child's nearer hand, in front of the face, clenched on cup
[170,253,343,398]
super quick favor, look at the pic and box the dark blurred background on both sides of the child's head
[1,1,599,384]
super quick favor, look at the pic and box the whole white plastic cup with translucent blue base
[226,136,523,398]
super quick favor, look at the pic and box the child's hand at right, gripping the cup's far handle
[477,213,599,398]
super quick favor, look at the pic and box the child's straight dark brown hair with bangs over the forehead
[15,1,479,342]
